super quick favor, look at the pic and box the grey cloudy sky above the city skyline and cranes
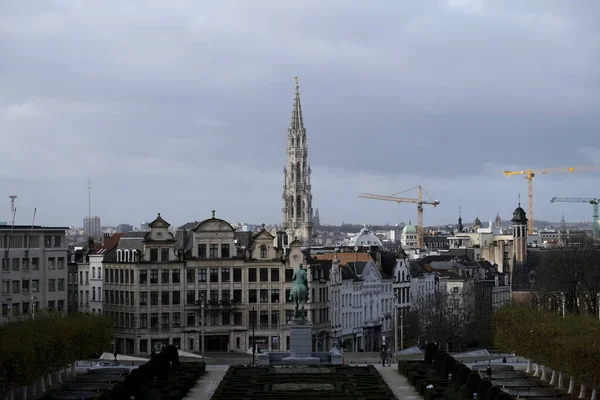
[0,0,600,226]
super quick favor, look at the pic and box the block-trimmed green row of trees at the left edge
[0,312,112,395]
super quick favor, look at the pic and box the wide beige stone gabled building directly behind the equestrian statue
[102,213,331,354]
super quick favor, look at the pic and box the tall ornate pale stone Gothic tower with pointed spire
[281,77,313,246]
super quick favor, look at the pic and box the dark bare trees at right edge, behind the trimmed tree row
[537,235,600,314]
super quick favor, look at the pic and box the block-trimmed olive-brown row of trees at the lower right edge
[492,303,600,386]
